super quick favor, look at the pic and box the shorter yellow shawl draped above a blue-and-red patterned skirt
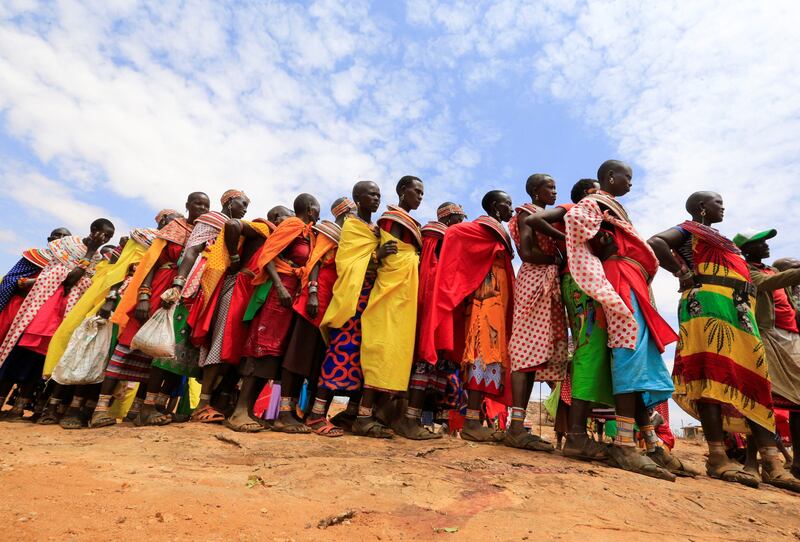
[319,218,380,342]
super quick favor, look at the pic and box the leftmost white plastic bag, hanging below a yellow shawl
[52,316,112,386]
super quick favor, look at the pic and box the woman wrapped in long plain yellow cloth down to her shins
[353,175,424,438]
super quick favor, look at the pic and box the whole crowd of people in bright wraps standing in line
[0,160,800,491]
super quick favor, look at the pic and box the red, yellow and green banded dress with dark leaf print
[672,224,775,432]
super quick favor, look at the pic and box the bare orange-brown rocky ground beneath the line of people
[0,423,800,542]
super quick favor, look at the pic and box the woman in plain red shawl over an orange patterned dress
[420,190,514,442]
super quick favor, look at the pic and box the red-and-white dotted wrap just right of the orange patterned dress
[508,204,569,381]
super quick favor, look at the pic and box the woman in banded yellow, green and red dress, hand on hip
[648,192,800,491]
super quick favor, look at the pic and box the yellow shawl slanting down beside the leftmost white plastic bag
[42,239,147,378]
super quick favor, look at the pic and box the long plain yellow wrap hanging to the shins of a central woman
[360,230,419,391]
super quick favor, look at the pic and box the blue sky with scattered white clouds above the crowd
[0,0,800,430]
